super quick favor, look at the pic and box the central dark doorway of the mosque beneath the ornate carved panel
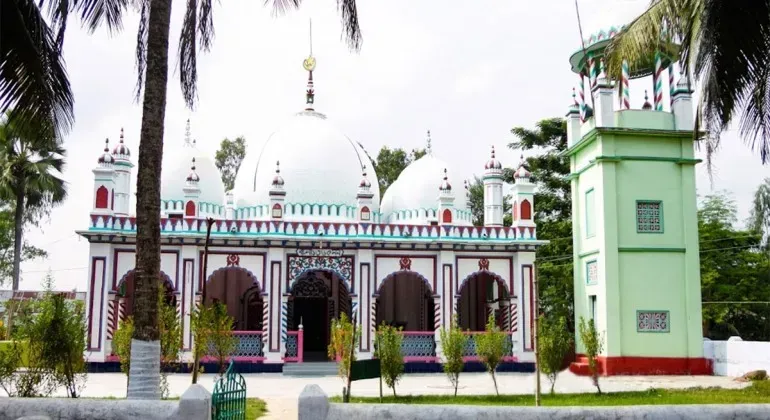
[286,269,352,362]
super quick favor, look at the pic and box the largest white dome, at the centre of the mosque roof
[234,111,380,219]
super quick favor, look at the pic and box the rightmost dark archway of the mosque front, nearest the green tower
[458,270,511,331]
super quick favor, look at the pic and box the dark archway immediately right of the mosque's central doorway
[375,271,435,331]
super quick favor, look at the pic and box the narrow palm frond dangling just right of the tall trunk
[179,0,198,108]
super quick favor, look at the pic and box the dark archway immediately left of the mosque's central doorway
[204,267,263,331]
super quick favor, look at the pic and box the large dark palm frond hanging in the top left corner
[0,0,74,136]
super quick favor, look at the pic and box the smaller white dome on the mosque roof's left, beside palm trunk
[160,142,225,206]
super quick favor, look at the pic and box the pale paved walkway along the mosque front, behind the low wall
[61,371,747,420]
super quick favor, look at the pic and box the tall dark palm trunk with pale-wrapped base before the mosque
[127,0,171,400]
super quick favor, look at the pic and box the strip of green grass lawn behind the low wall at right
[330,381,770,406]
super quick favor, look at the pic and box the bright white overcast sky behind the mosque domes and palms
[16,0,770,290]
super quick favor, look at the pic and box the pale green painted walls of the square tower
[566,110,703,357]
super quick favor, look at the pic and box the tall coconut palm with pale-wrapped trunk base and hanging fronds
[63,0,361,399]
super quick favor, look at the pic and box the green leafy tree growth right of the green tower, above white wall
[698,194,770,341]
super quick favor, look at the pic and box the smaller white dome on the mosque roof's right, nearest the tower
[380,154,466,224]
